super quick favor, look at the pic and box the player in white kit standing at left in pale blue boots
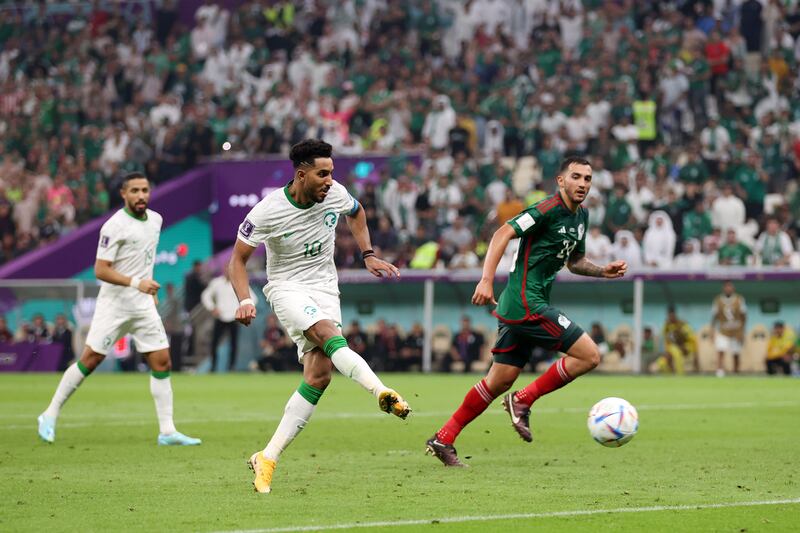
[38,172,201,446]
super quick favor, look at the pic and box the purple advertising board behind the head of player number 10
[211,156,418,242]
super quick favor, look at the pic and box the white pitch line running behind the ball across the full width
[0,401,800,429]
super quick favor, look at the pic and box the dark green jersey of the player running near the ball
[494,192,588,322]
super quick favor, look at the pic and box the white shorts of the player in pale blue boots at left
[86,305,169,355]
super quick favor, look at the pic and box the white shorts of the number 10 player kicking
[264,285,342,363]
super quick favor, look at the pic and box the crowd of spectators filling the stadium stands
[0,0,800,269]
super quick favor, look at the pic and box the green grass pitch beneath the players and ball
[0,374,800,532]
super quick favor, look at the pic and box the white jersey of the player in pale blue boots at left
[97,209,162,314]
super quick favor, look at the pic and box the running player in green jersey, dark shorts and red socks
[426,156,628,466]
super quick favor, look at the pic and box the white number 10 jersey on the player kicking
[238,181,358,294]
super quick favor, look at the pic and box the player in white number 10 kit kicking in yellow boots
[229,139,411,493]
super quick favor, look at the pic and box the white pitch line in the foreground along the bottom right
[212,498,800,533]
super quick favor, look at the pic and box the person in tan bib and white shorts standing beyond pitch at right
[711,281,747,378]
